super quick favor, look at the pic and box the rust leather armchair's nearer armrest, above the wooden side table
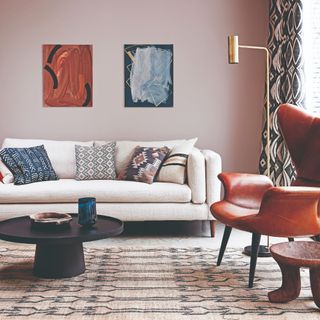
[241,187,320,237]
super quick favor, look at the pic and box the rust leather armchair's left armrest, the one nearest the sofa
[218,172,273,209]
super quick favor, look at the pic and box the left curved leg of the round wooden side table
[268,261,301,303]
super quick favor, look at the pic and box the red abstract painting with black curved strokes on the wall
[43,44,92,107]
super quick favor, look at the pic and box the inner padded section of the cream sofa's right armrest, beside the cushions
[187,148,206,204]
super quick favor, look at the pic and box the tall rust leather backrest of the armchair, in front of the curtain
[277,104,320,187]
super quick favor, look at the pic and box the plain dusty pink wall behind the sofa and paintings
[0,0,268,172]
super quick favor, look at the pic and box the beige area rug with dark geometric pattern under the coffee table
[0,245,320,320]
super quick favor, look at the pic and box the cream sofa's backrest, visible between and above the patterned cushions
[2,138,185,179]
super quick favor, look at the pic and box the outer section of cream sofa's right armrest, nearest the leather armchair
[201,150,222,207]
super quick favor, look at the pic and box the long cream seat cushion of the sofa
[0,179,191,203]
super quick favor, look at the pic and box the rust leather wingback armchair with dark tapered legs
[211,104,320,288]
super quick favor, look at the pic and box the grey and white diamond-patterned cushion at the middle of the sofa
[75,141,116,180]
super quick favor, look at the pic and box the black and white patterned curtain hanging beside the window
[259,0,305,186]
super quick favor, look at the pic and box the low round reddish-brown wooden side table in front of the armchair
[268,241,320,308]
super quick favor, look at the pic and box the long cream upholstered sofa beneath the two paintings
[0,139,221,226]
